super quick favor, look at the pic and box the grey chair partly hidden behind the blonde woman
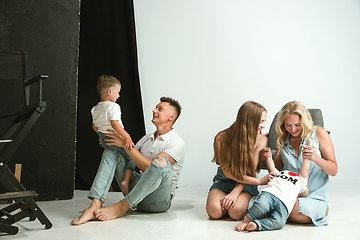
[260,108,330,169]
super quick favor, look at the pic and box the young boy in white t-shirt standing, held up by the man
[91,75,135,195]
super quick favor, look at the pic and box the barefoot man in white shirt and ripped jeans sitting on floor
[71,97,185,225]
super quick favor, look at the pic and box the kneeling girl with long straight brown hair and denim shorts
[206,101,270,220]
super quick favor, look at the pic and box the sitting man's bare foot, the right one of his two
[94,199,130,221]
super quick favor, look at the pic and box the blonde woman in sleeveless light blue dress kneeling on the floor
[261,101,338,226]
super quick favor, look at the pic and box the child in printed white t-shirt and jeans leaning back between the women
[235,146,311,232]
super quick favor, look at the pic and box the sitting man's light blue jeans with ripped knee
[88,149,172,212]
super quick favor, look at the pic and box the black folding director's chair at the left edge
[0,52,52,234]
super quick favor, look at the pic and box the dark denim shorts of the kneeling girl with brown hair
[209,168,259,197]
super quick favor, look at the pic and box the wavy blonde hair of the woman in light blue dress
[276,101,316,158]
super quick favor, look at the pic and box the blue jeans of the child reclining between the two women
[246,192,288,231]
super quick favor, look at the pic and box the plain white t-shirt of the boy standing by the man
[91,101,124,133]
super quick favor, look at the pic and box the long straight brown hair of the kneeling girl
[212,101,266,180]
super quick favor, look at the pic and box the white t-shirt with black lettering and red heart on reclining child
[262,169,308,214]
